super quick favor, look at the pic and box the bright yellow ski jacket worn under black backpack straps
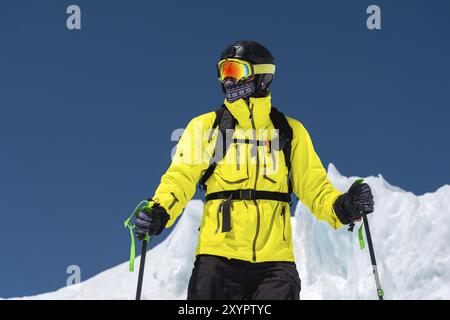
[153,95,342,262]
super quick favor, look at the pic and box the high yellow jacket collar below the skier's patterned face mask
[224,93,272,129]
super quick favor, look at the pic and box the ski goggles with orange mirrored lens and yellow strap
[217,59,275,81]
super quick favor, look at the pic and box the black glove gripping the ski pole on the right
[333,181,374,224]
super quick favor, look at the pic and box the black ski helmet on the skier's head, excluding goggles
[219,41,275,97]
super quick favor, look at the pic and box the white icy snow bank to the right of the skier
[293,165,450,299]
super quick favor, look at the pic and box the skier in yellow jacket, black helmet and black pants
[135,41,374,300]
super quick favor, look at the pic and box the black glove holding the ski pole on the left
[134,203,170,240]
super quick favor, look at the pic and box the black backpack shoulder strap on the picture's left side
[199,104,237,191]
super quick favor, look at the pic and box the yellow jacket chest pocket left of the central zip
[216,142,249,184]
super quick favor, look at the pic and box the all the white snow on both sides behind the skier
[10,164,450,299]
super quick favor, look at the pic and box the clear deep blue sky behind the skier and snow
[0,0,450,297]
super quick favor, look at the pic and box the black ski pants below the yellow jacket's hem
[187,255,300,300]
